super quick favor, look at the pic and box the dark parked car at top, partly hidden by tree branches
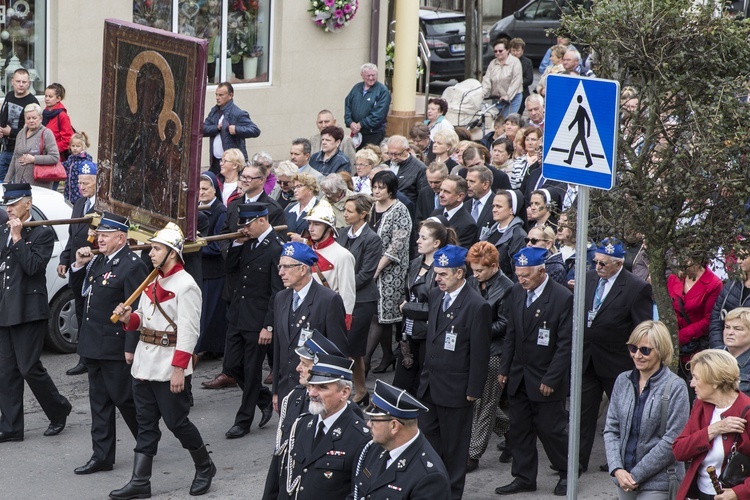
[490,0,591,61]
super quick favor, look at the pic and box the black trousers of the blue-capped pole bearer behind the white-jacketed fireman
[224,325,273,428]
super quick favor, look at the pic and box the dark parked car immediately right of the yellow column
[419,7,494,82]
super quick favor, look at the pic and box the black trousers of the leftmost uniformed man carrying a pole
[0,319,70,436]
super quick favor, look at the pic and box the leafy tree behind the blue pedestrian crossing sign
[560,0,750,337]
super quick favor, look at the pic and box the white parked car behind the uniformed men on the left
[2,186,78,353]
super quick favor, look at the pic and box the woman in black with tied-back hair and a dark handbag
[393,217,458,394]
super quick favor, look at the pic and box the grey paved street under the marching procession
[0,353,616,500]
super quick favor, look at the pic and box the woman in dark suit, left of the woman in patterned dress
[337,193,383,406]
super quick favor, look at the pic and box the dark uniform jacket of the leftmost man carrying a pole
[0,220,55,326]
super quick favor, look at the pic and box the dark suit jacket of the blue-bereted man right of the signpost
[583,269,654,378]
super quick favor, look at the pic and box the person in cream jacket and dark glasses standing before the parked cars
[482,38,523,116]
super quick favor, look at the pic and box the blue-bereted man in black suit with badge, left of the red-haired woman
[418,246,492,500]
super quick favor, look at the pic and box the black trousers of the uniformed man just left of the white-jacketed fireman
[82,358,138,465]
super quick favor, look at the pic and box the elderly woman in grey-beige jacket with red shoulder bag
[5,103,60,189]
